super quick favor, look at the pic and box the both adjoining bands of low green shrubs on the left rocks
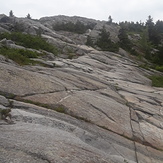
[0,32,57,65]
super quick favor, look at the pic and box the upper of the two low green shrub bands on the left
[0,32,57,54]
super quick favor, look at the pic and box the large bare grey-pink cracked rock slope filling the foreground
[0,14,163,163]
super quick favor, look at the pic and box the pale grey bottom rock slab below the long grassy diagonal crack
[0,101,162,163]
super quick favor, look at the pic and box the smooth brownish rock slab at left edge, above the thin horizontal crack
[0,63,64,95]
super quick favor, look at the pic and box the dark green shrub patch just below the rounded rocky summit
[53,21,95,34]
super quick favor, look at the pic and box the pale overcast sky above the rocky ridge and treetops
[0,0,163,22]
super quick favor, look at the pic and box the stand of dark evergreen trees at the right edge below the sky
[119,16,163,66]
